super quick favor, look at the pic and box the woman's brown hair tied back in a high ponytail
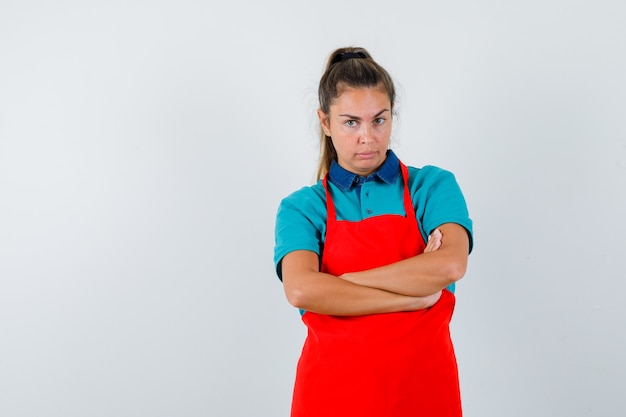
[317,47,396,180]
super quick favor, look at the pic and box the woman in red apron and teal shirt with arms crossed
[274,48,472,417]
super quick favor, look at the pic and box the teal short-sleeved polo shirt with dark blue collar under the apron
[274,150,473,290]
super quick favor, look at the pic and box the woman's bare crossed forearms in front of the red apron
[282,223,469,316]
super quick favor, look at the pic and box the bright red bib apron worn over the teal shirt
[291,163,461,417]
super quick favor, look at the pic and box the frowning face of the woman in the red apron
[318,87,392,176]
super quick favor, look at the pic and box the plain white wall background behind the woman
[0,0,626,417]
